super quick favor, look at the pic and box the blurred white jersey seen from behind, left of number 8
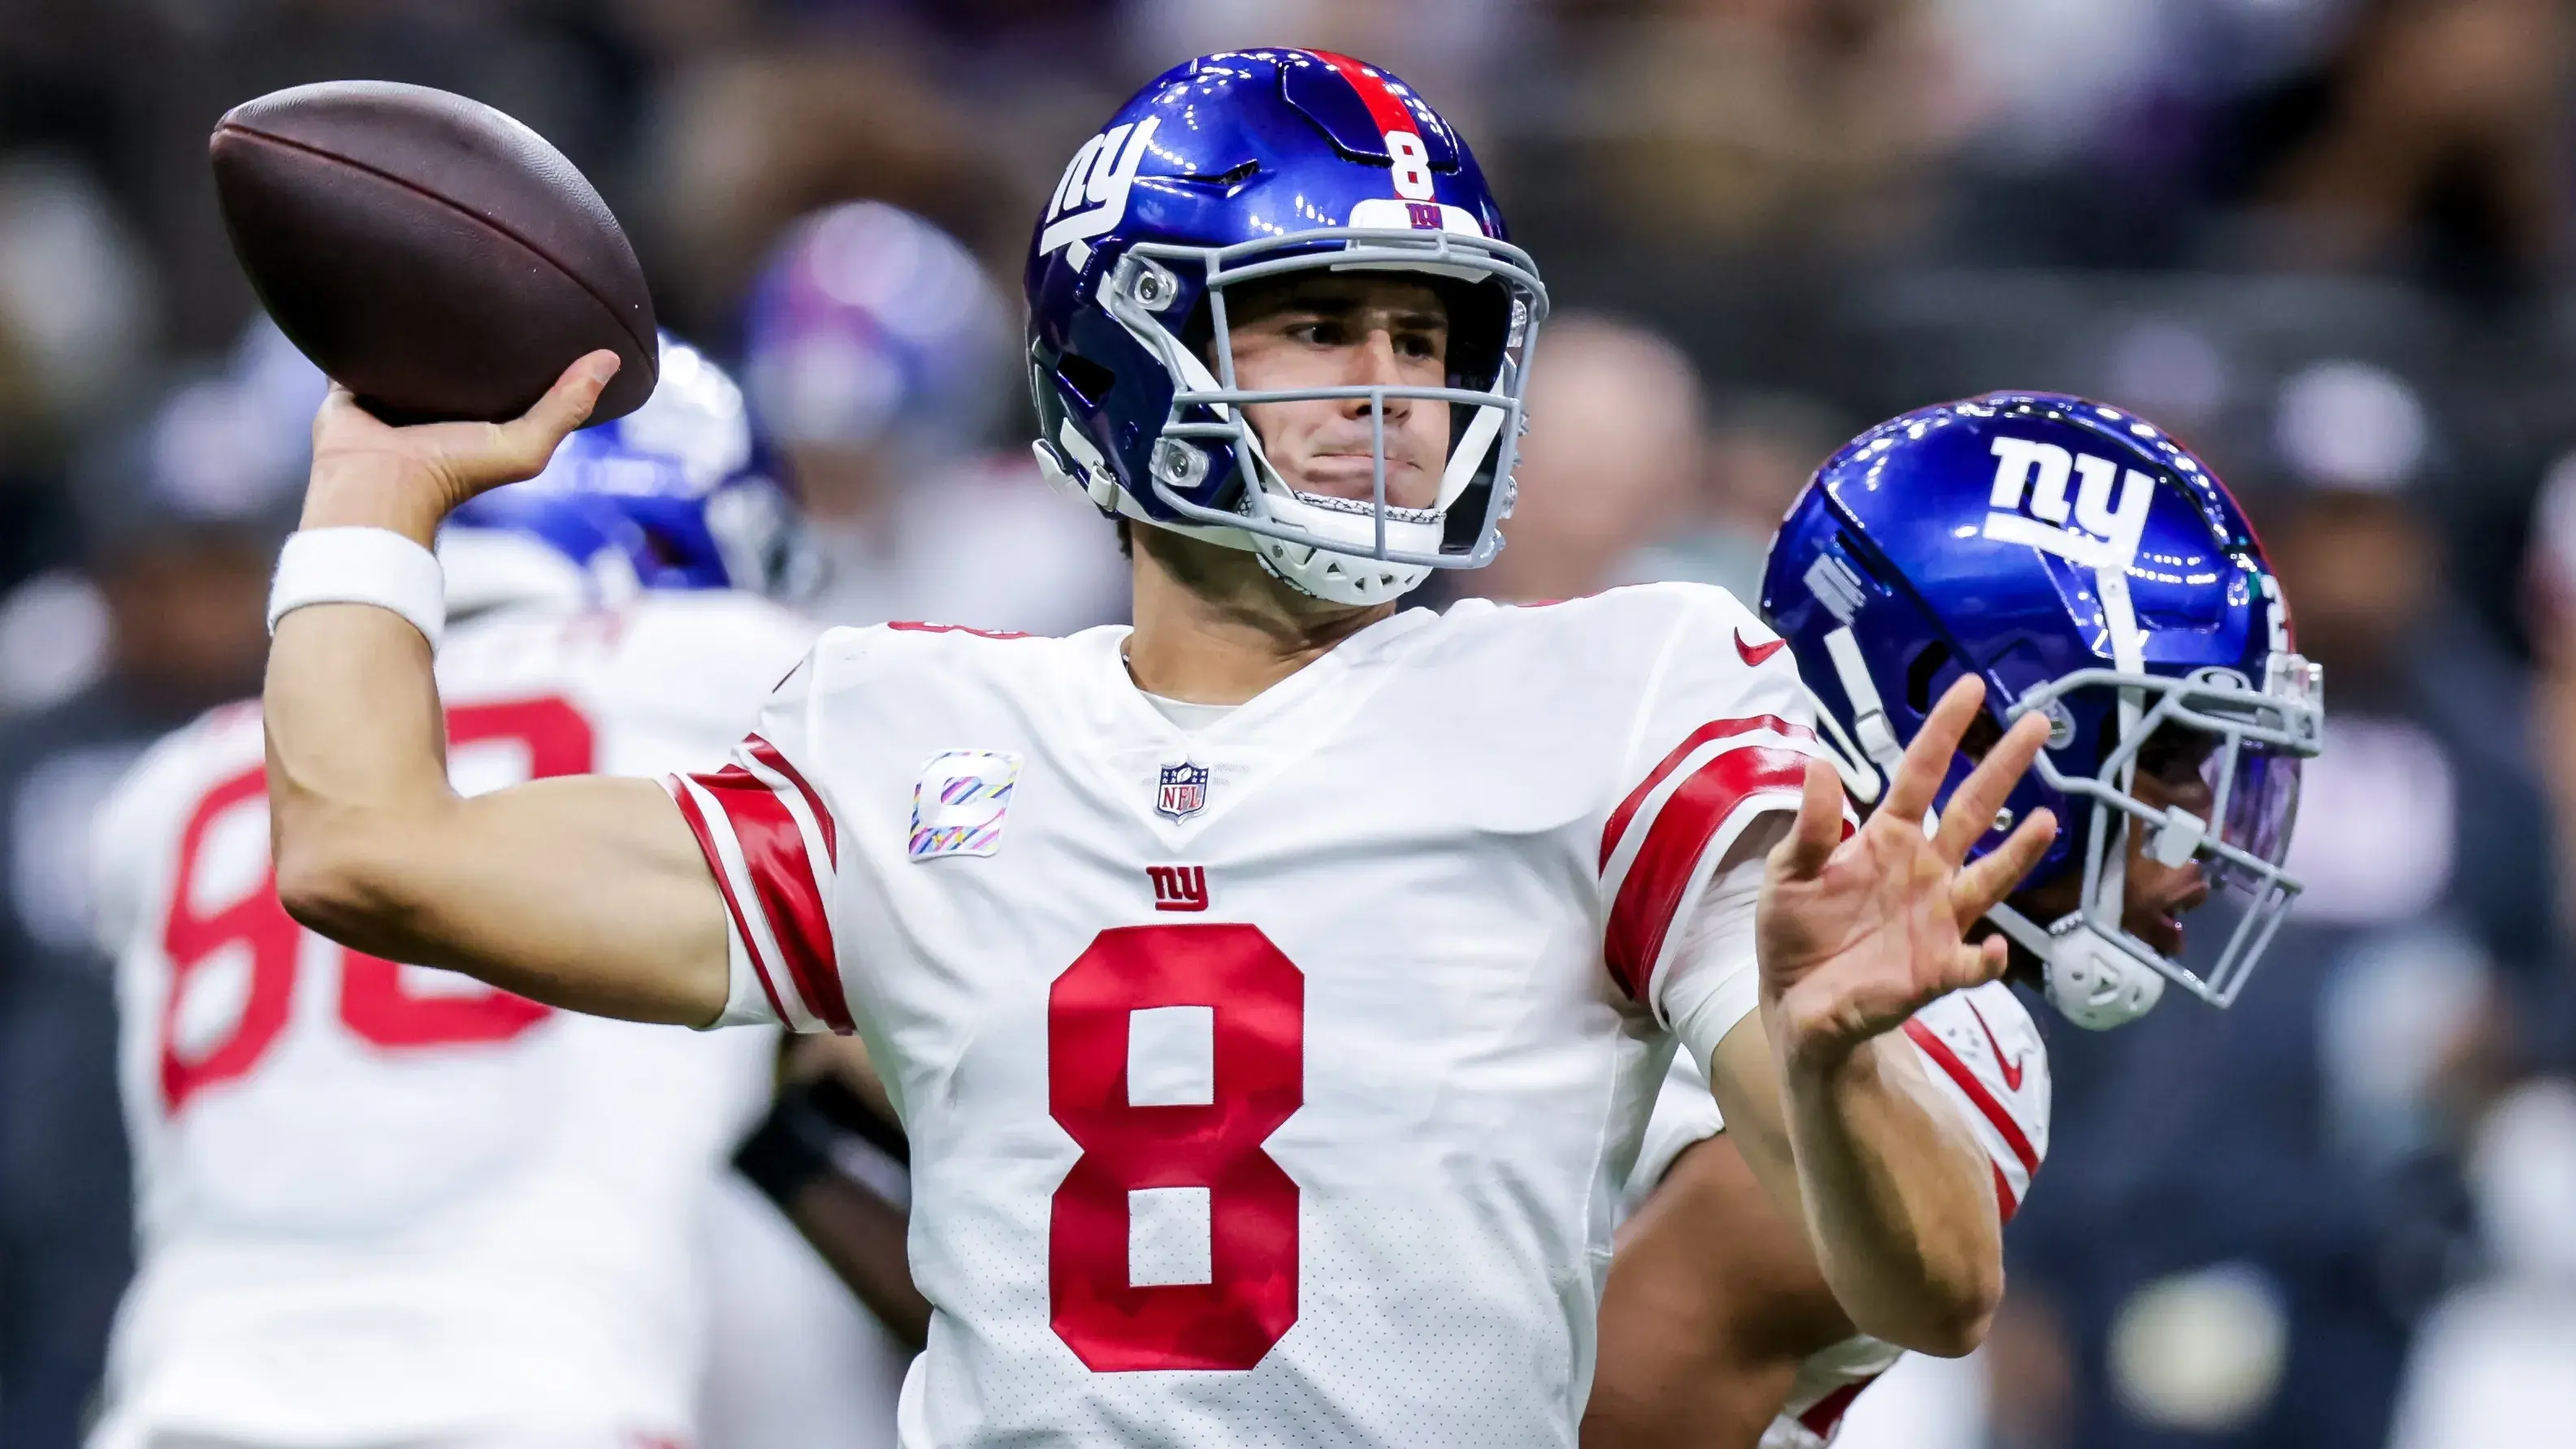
[95,592,812,1447]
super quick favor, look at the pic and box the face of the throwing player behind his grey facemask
[1226,273,1450,507]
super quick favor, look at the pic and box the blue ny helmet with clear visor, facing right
[1762,394,2323,1027]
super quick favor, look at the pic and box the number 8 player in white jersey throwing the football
[266,49,2055,1447]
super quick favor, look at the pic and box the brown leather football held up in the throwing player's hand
[206,80,660,422]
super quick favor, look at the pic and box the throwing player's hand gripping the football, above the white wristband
[304,350,618,543]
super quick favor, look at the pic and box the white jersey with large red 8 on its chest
[673,584,1811,1449]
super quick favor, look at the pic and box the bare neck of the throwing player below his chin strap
[1126,528,1396,705]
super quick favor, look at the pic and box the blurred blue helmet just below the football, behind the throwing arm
[440,332,809,608]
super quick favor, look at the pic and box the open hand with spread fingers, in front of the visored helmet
[1754,674,2059,1071]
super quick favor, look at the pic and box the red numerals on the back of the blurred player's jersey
[160,700,592,1117]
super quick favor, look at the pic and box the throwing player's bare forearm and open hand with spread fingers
[1711,677,2055,1356]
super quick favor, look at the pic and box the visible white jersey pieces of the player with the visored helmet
[1623,980,2048,1449]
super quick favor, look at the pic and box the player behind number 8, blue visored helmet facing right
[1584,394,2321,1449]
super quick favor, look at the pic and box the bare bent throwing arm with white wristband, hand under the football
[266,353,726,1024]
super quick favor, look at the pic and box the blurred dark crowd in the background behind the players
[15,0,2576,1449]
